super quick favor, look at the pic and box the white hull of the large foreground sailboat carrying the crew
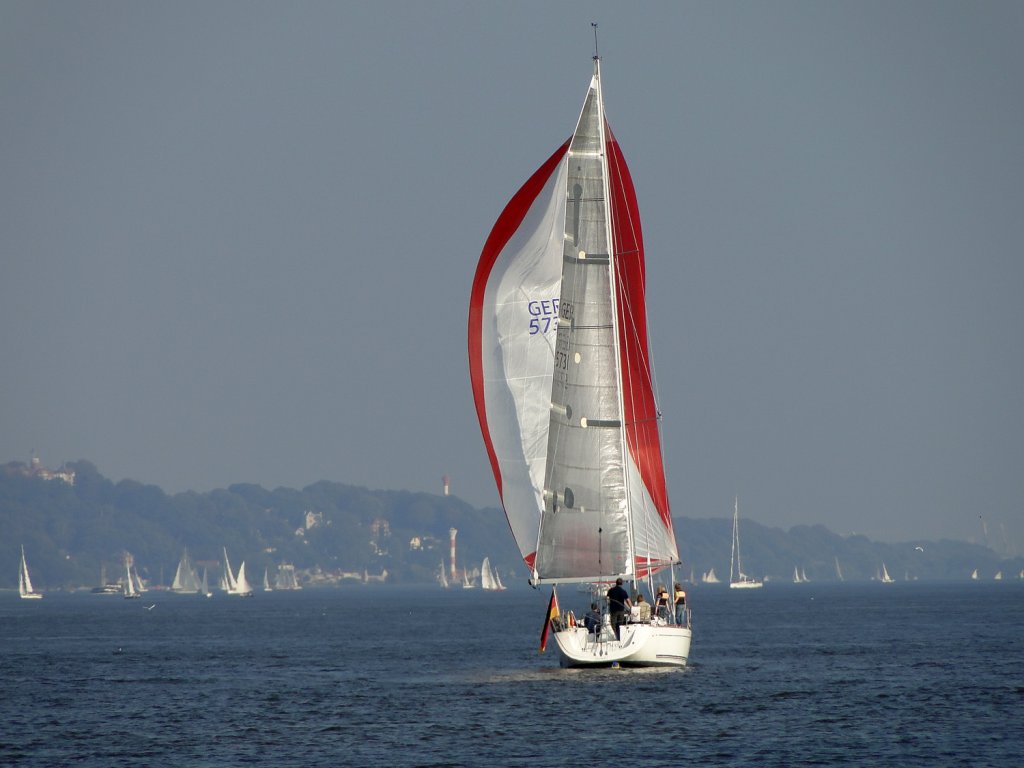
[554,624,693,667]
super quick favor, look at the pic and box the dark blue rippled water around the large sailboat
[0,582,1024,767]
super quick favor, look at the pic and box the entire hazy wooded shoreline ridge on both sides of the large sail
[0,461,1024,589]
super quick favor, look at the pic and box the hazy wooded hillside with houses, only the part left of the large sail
[0,461,525,589]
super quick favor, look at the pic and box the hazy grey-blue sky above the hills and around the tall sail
[0,0,1024,548]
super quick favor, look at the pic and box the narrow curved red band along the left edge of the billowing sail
[469,139,571,567]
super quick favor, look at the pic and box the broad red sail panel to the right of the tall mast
[604,121,672,531]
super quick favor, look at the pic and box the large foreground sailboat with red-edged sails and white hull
[469,56,691,667]
